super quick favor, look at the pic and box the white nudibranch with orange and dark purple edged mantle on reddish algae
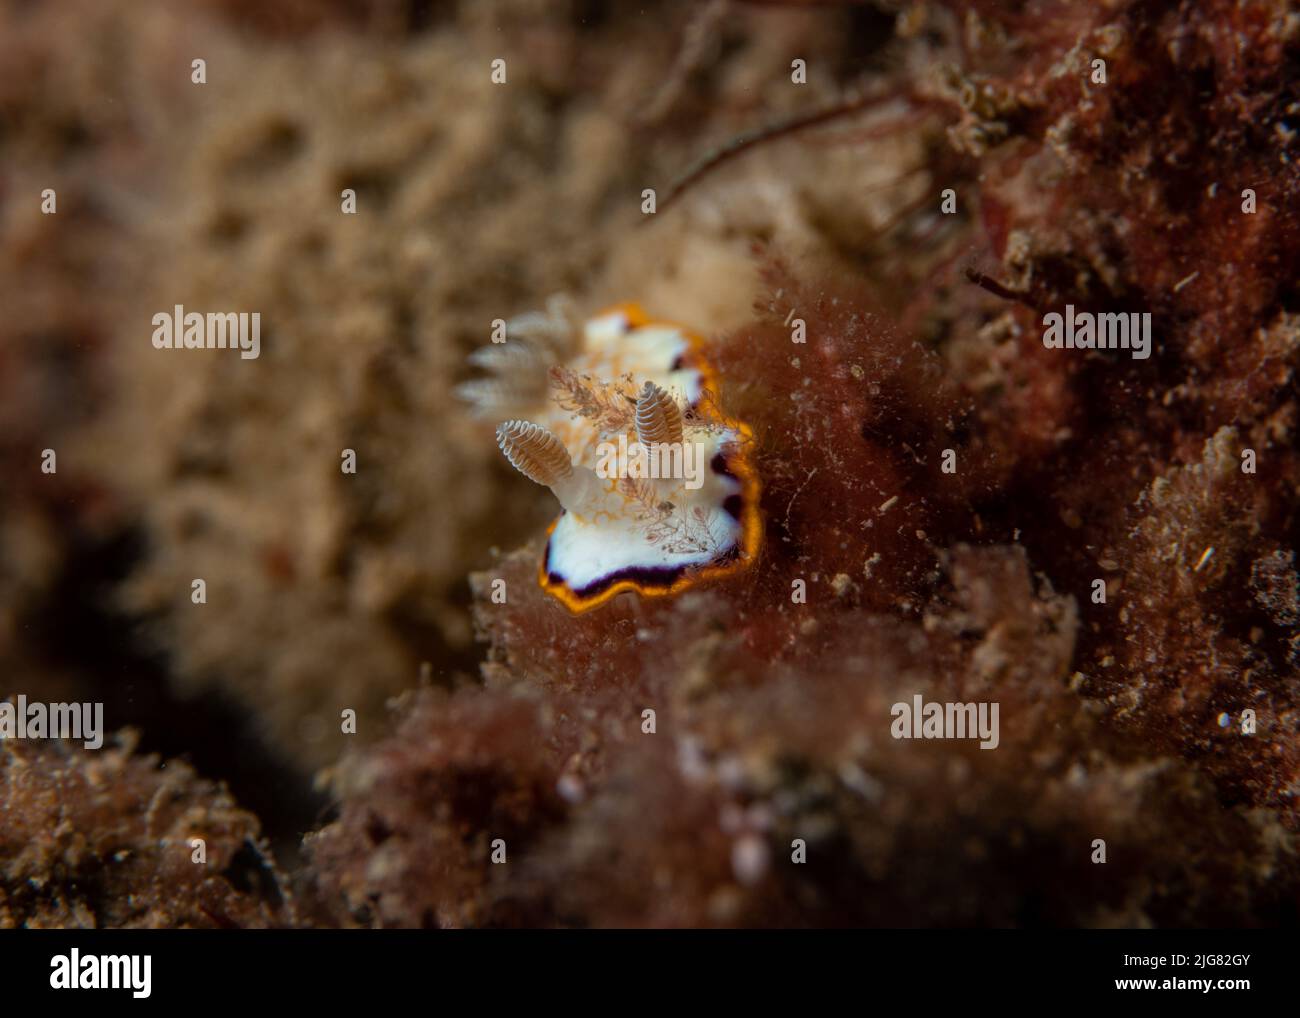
[458,302,762,612]
